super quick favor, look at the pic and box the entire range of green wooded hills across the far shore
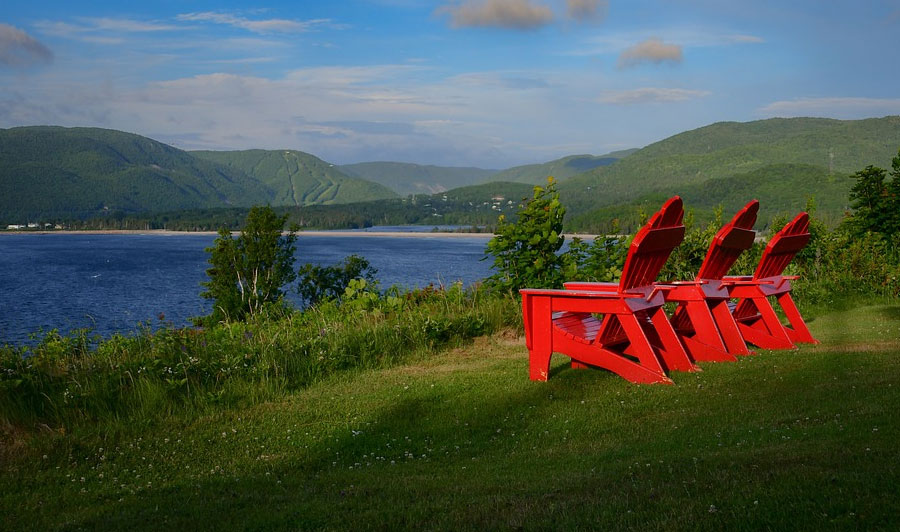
[0,116,900,232]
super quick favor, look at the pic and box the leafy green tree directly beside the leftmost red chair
[486,177,572,290]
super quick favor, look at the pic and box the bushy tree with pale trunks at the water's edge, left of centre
[200,206,297,323]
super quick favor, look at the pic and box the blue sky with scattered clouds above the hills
[0,0,900,168]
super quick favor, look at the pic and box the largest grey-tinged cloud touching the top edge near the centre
[436,0,553,30]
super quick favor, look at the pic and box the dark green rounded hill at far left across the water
[0,126,269,219]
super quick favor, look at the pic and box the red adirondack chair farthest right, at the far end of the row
[724,212,819,349]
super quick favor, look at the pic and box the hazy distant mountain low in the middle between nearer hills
[339,162,497,196]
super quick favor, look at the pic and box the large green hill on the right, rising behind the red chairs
[559,116,900,220]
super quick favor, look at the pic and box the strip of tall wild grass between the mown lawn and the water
[0,285,521,428]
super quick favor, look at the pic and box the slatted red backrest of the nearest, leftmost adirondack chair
[619,196,684,292]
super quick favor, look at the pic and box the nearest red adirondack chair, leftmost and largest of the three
[520,196,697,383]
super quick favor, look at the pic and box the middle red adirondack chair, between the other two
[565,200,759,361]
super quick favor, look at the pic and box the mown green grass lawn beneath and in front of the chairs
[0,305,900,530]
